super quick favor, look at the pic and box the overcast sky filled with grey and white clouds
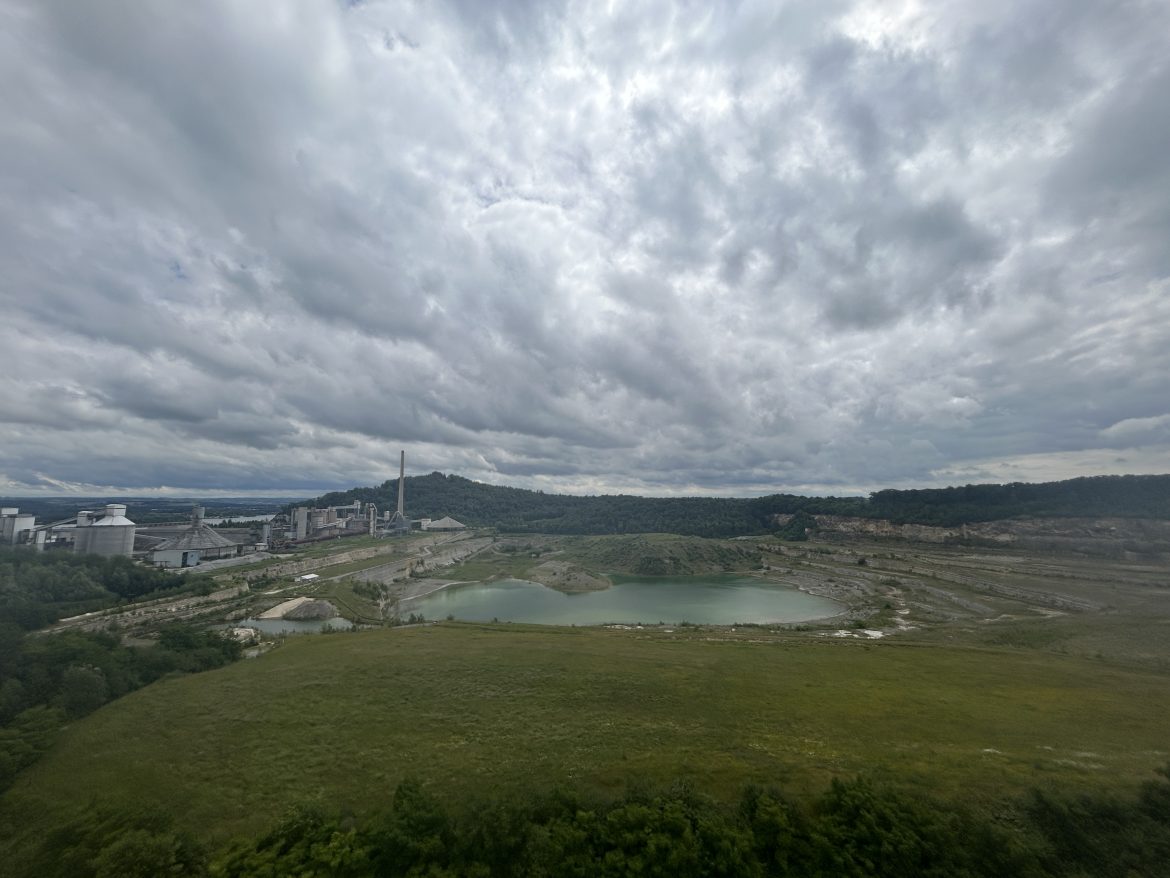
[0,0,1170,495]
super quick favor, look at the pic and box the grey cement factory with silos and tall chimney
[0,451,464,569]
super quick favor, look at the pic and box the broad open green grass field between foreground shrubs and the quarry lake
[0,624,1170,862]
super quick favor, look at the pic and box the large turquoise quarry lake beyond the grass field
[400,575,844,625]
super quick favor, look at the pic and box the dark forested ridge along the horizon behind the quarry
[312,473,1170,536]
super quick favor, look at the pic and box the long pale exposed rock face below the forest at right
[776,515,1170,557]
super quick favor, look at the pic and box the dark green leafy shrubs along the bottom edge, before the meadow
[18,778,1170,878]
